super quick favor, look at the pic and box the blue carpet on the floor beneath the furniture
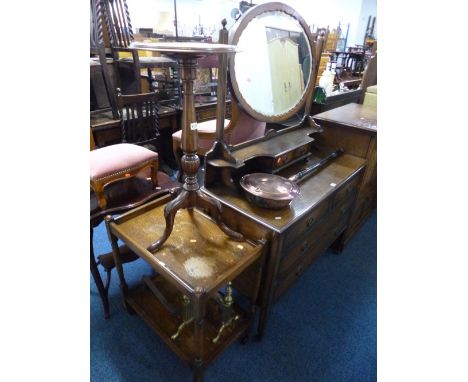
[91,211,377,382]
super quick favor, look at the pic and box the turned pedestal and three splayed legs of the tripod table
[148,47,244,253]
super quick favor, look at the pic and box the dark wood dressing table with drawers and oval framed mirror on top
[202,3,372,338]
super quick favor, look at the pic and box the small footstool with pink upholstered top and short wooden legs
[90,143,158,209]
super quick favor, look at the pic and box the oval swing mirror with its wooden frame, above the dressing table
[229,2,315,122]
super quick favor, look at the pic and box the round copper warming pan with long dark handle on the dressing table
[239,149,343,209]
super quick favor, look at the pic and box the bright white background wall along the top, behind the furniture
[127,0,377,46]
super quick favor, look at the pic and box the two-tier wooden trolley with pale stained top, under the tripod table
[106,196,264,381]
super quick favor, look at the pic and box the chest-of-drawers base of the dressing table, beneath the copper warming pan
[204,154,365,337]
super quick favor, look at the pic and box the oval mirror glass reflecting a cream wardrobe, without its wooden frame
[234,11,312,117]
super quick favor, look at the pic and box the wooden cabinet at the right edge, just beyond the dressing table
[314,103,377,250]
